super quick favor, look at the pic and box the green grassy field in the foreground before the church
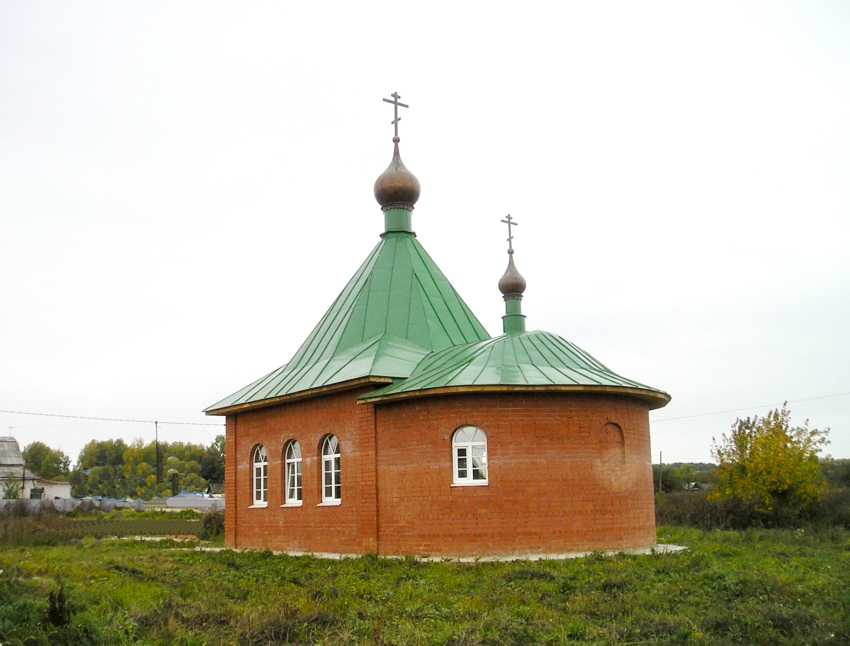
[0,527,850,646]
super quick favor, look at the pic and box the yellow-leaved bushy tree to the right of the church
[709,404,829,522]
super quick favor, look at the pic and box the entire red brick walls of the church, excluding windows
[225,387,655,556]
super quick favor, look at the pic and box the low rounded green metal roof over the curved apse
[361,331,670,408]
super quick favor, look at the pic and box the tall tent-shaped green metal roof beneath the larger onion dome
[201,232,490,412]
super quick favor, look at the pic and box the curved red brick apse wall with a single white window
[376,393,655,556]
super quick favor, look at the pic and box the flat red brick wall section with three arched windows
[225,387,377,553]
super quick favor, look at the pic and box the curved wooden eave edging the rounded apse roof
[358,384,670,410]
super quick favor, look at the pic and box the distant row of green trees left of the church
[23,435,224,500]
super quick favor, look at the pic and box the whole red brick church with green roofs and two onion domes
[205,95,670,556]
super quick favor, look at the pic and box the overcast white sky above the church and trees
[0,0,850,462]
